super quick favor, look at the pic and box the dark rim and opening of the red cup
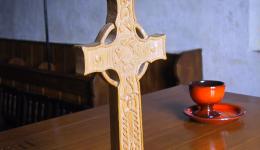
[189,80,225,87]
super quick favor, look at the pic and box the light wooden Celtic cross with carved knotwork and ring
[82,0,166,150]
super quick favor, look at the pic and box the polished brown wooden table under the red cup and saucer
[0,86,260,150]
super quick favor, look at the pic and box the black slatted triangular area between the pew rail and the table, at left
[0,86,89,131]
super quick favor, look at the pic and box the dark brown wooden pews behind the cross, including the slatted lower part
[0,39,202,130]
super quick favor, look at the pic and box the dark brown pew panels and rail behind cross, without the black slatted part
[0,39,202,107]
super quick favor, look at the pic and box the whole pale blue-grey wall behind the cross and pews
[0,0,260,96]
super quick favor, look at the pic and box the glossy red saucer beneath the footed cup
[184,103,246,124]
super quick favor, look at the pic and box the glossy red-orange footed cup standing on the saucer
[189,80,225,118]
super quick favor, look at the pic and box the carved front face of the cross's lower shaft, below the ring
[119,77,142,149]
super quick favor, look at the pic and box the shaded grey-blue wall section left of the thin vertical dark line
[0,0,45,40]
